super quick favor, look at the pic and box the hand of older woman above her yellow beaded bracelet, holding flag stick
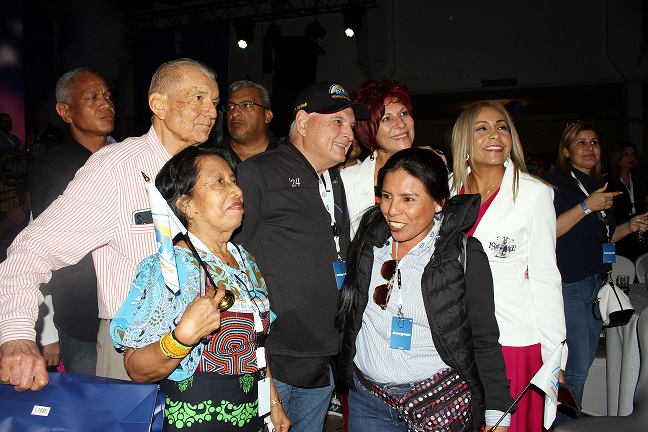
[174,287,225,345]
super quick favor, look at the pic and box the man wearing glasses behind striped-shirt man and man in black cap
[220,80,279,163]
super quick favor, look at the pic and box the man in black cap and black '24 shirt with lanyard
[235,82,369,432]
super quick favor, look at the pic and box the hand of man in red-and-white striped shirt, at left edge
[0,339,49,391]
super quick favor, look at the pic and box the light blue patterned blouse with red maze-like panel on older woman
[110,243,275,381]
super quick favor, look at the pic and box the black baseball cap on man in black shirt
[293,81,370,120]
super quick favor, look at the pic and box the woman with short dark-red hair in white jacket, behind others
[341,78,414,237]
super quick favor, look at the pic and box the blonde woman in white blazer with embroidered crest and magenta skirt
[451,101,567,432]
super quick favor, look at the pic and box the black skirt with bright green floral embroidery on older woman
[160,372,263,432]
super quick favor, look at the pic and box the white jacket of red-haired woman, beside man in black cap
[340,153,376,239]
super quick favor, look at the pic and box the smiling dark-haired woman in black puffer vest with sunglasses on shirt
[337,148,513,432]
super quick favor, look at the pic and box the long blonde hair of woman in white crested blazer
[452,101,528,200]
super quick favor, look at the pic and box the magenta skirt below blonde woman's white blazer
[502,343,544,432]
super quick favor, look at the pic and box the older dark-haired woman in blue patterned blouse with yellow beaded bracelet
[110,147,290,432]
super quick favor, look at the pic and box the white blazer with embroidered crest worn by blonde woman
[453,163,567,366]
